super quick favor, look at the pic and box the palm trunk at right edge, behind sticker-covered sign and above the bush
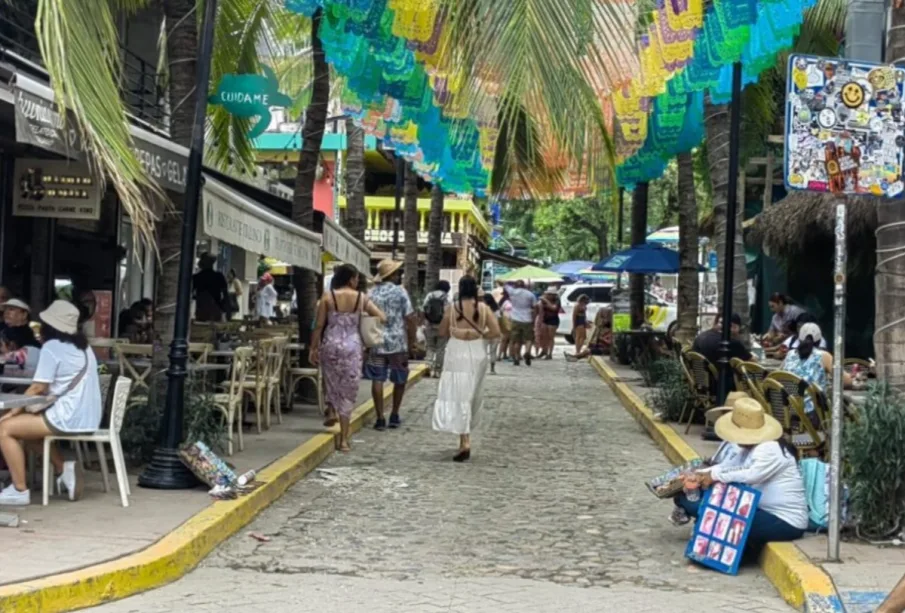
[872,4,905,389]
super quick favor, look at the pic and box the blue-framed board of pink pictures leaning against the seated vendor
[685,483,760,575]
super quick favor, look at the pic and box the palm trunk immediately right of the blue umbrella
[676,152,698,342]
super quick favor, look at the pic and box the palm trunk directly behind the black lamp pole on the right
[704,102,750,327]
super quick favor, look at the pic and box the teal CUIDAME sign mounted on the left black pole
[207,66,292,138]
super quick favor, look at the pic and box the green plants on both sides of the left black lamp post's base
[120,377,226,465]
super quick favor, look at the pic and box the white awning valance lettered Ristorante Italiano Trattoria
[202,175,321,272]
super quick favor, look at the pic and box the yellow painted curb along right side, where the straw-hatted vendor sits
[590,356,836,610]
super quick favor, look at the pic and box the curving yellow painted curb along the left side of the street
[0,366,427,613]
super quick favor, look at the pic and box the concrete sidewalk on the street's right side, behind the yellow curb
[606,361,905,613]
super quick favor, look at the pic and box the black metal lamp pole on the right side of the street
[717,62,742,405]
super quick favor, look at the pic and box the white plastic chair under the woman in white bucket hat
[42,377,132,507]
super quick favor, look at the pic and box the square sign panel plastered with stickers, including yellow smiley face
[785,55,905,198]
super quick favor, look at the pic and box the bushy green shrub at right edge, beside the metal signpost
[844,382,905,538]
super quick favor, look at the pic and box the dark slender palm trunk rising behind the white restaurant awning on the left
[292,9,330,360]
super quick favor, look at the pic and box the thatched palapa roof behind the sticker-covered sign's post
[745,191,882,258]
